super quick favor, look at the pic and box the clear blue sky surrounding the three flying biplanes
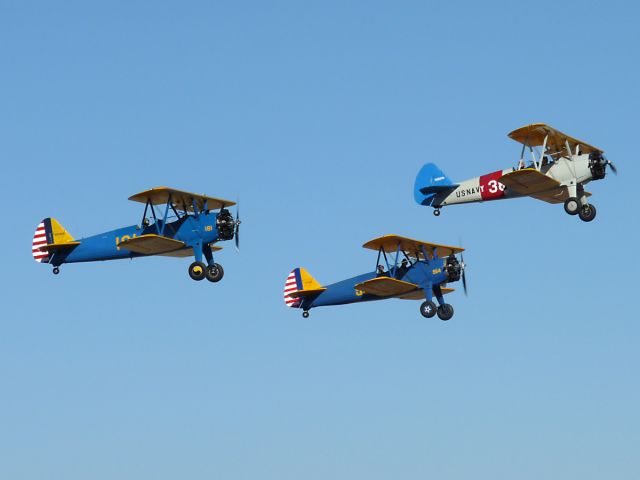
[0,0,640,480]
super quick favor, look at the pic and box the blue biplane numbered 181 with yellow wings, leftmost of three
[31,187,240,282]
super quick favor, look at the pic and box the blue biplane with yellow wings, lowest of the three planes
[284,235,467,320]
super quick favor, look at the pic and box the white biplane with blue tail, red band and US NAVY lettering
[414,123,617,222]
